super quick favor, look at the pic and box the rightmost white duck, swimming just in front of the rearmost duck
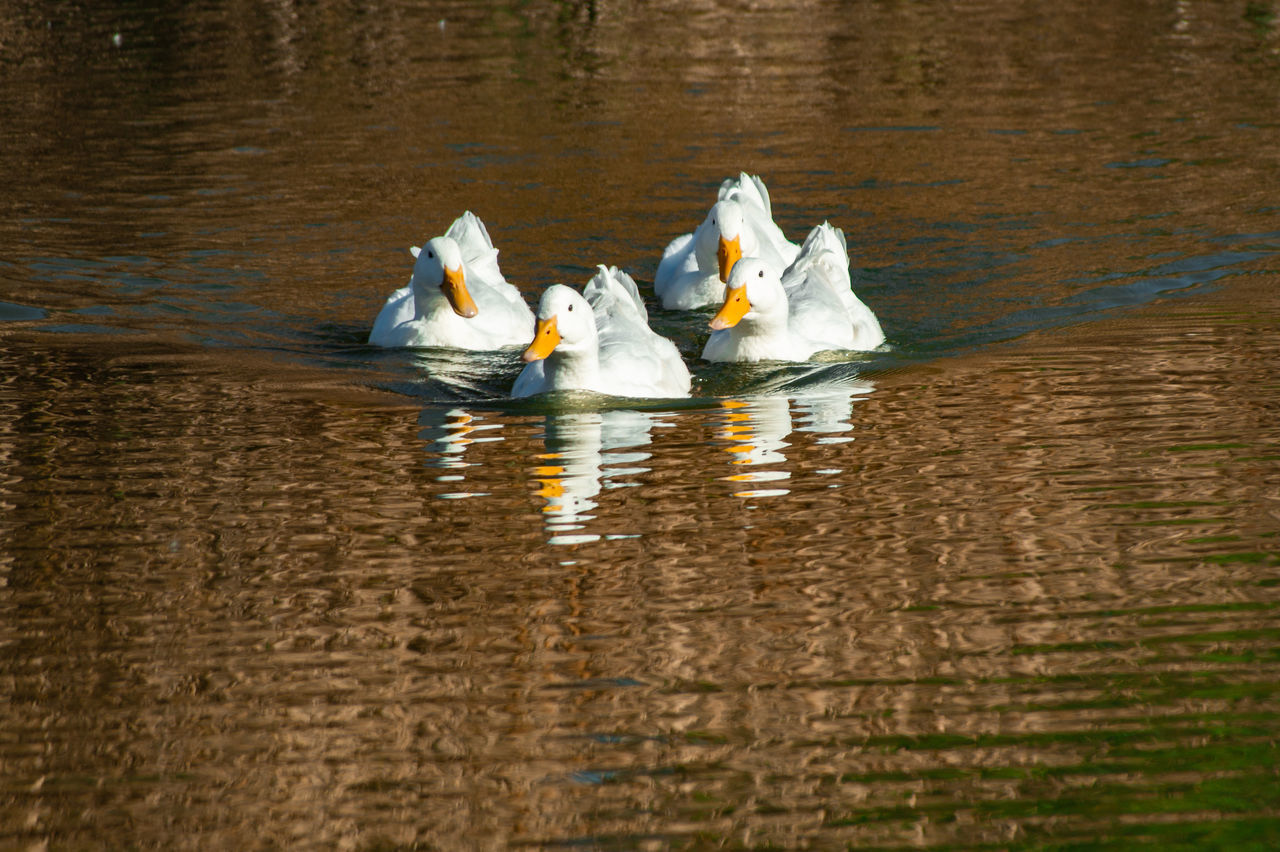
[703,223,884,361]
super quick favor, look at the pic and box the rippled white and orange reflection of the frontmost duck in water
[534,409,659,544]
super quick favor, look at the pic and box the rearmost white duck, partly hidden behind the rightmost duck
[653,171,800,311]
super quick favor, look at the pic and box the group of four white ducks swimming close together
[369,173,884,398]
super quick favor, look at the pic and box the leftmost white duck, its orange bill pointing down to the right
[369,211,534,349]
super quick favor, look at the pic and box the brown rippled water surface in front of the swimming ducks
[3,290,1280,848]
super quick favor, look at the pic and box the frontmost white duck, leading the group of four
[511,265,690,398]
